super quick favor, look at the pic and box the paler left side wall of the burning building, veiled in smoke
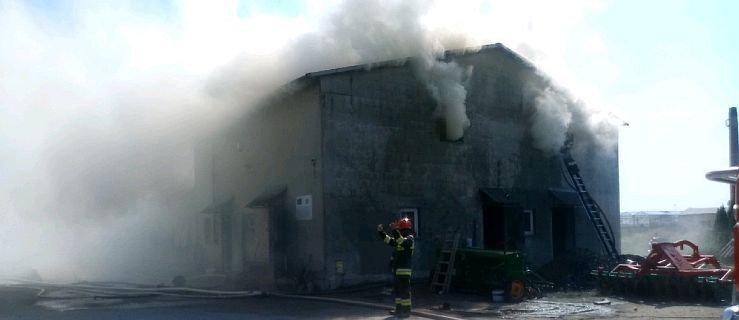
[197,85,324,286]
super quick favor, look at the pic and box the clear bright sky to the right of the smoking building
[580,1,739,210]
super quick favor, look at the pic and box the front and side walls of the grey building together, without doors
[196,43,619,287]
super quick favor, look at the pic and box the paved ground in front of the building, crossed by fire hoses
[0,287,723,320]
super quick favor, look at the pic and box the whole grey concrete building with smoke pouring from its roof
[193,44,619,288]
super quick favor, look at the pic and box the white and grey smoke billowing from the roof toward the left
[0,0,612,280]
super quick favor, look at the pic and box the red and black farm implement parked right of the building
[593,240,734,302]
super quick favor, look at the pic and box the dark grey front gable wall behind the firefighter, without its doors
[320,45,619,287]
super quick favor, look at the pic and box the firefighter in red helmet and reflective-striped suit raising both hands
[377,218,414,318]
